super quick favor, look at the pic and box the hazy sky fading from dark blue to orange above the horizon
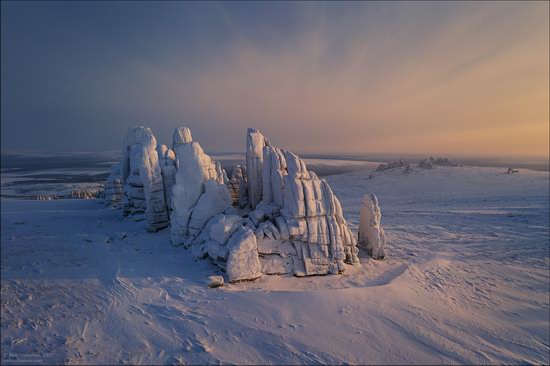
[1,1,550,157]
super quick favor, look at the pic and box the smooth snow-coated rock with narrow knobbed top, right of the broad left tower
[170,128,232,246]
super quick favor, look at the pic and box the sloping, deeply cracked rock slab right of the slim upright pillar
[260,140,359,276]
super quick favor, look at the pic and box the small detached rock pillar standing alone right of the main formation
[359,194,386,259]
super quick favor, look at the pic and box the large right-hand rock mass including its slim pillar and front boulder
[188,129,359,282]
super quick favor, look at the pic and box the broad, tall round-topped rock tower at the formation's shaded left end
[121,126,169,231]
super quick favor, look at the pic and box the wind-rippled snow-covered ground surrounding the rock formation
[1,167,550,364]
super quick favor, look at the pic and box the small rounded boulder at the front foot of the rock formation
[226,227,262,282]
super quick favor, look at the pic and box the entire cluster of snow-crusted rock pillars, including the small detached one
[105,126,386,282]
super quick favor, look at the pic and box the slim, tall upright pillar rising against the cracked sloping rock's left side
[246,128,269,209]
